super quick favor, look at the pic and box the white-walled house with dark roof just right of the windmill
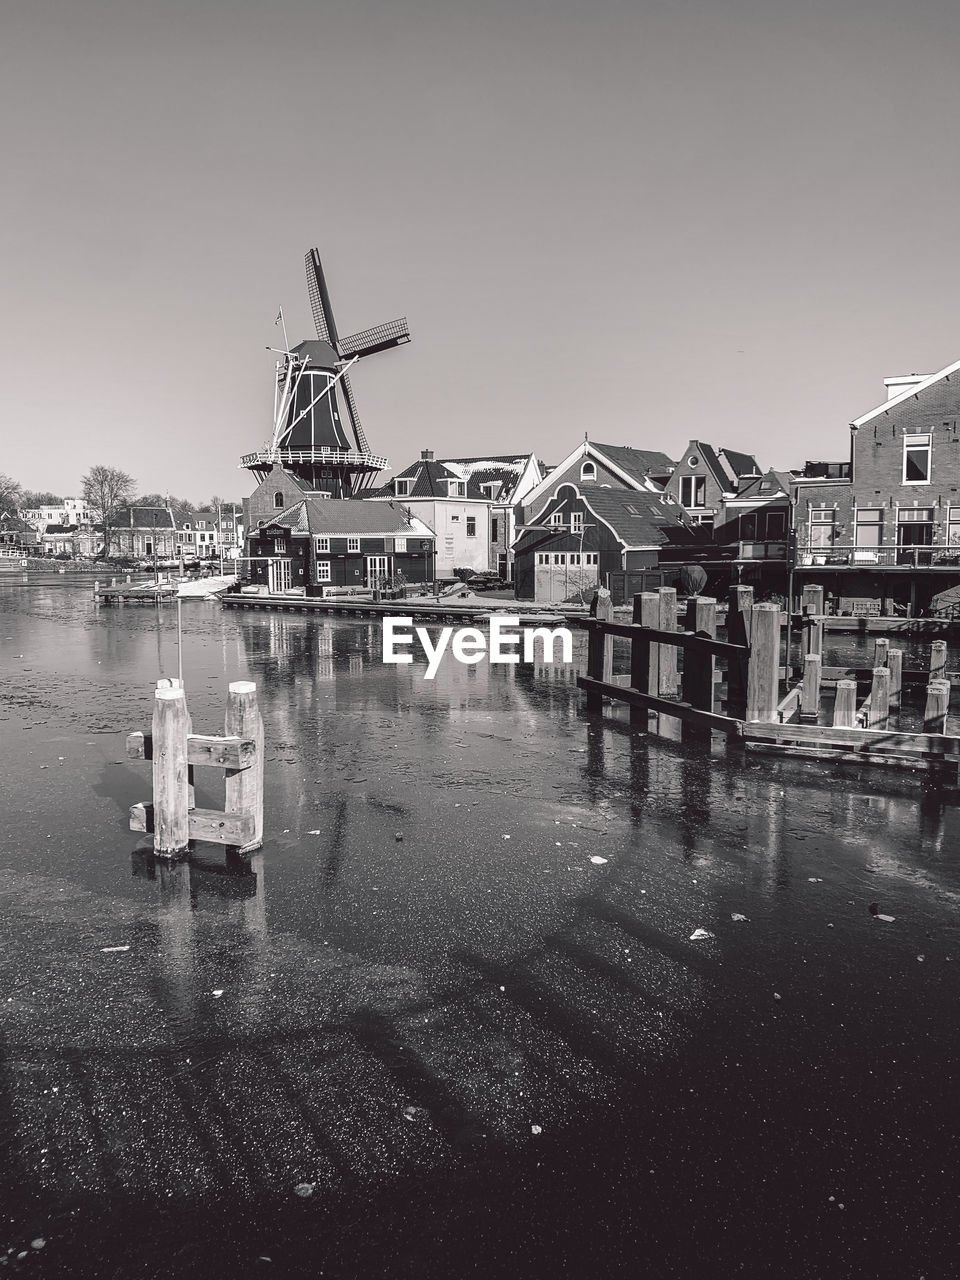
[365,449,541,581]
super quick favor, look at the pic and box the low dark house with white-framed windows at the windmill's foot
[243,495,434,595]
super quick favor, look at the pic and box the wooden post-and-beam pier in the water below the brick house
[577,586,960,783]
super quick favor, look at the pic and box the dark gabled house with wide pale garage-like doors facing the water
[513,483,694,603]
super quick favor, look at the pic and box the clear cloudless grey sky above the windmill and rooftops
[0,0,960,499]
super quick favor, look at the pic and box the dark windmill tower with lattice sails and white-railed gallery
[241,248,410,498]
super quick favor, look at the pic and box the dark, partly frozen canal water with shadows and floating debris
[0,579,960,1280]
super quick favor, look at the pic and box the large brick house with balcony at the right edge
[794,361,960,616]
